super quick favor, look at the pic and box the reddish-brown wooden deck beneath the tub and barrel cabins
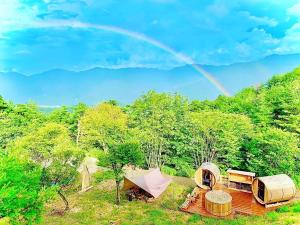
[181,185,278,218]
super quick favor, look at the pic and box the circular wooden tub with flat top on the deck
[205,190,232,216]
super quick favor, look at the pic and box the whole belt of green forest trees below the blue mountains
[0,68,300,224]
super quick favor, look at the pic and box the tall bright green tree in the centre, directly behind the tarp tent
[127,91,189,167]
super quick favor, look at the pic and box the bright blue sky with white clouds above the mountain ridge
[0,0,300,74]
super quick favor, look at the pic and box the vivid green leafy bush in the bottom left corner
[0,156,44,224]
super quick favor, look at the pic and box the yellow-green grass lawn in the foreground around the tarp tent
[43,178,300,225]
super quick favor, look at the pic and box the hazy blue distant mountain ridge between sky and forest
[0,54,300,106]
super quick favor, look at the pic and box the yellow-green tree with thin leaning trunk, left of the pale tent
[12,123,84,210]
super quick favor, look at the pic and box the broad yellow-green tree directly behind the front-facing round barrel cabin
[189,111,253,171]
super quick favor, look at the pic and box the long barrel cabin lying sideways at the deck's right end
[252,174,296,206]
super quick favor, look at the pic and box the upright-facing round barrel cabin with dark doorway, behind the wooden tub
[195,162,220,190]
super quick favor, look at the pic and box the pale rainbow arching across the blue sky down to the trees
[12,20,230,96]
